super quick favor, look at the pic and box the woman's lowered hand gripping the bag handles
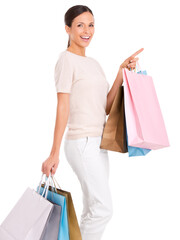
[41,154,59,177]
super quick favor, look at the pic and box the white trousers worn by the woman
[64,136,113,240]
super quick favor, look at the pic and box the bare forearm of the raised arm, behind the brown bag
[106,69,123,115]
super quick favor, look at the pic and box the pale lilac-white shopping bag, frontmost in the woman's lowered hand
[0,175,53,240]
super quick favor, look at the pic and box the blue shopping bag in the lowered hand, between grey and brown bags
[37,177,70,240]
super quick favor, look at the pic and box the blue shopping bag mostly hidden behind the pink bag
[126,69,151,157]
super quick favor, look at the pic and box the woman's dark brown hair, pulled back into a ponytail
[64,5,94,47]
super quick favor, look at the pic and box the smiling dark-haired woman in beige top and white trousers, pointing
[42,5,143,240]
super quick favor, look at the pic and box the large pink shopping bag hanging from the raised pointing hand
[123,68,169,150]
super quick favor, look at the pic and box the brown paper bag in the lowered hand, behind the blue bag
[41,176,82,240]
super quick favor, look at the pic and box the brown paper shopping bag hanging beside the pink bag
[100,86,128,153]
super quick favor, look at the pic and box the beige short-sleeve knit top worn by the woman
[54,50,110,139]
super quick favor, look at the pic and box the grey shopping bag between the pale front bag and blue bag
[40,203,61,240]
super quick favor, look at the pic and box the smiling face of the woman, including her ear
[65,12,94,47]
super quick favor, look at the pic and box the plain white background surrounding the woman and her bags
[0,0,180,240]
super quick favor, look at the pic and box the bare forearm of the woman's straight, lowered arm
[50,105,69,155]
